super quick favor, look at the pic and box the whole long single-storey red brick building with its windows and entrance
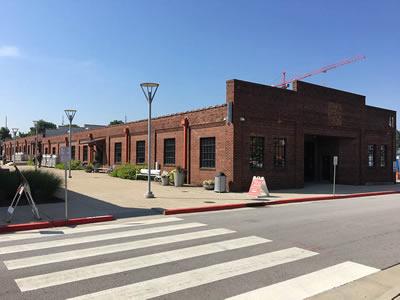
[5,80,396,191]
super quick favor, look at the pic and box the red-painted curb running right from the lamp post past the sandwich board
[164,191,400,215]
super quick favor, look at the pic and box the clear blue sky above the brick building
[0,0,400,131]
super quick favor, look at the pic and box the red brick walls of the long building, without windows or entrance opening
[10,80,396,191]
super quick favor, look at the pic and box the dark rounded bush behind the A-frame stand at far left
[0,170,62,205]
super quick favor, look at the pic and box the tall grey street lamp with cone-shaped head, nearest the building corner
[140,82,159,198]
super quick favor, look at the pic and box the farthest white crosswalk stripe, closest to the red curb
[0,217,182,242]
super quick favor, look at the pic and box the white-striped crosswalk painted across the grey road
[0,217,379,300]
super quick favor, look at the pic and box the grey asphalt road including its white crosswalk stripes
[0,195,400,300]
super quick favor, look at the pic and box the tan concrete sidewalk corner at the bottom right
[308,265,400,300]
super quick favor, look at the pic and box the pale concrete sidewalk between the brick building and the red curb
[0,167,400,225]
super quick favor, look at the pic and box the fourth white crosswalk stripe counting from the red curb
[15,236,270,292]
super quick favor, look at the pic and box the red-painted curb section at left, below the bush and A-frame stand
[0,215,115,233]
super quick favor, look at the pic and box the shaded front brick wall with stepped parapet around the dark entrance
[227,80,395,190]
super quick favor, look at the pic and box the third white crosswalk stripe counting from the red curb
[4,228,235,270]
